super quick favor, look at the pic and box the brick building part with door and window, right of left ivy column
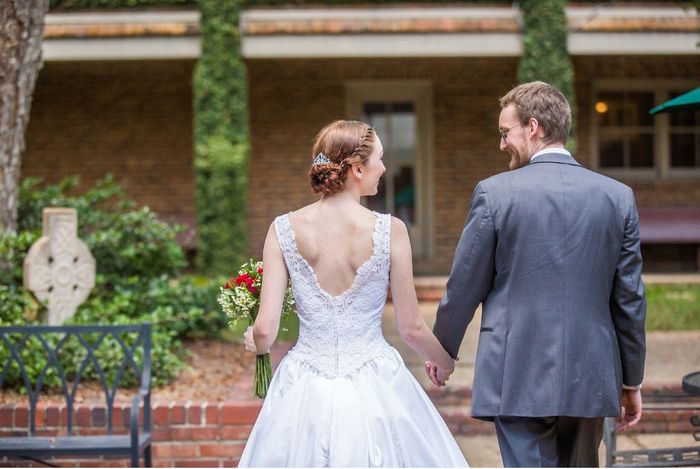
[241,5,700,274]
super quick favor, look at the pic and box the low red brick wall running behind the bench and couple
[0,388,698,467]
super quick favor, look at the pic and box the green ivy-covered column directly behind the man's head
[518,0,576,152]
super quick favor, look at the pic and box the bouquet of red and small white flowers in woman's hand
[218,259,295,398]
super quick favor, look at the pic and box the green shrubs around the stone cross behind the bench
[0,177,227,388]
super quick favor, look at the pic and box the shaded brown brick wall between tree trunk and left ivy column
[22,60,195,236]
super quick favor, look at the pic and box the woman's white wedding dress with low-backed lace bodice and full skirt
[239,213,467,467]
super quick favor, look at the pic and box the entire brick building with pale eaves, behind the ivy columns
[22,5,700,274]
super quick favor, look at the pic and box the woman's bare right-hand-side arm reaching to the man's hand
[390,217,454,371]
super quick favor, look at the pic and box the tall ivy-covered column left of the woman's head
[194,0,248,274]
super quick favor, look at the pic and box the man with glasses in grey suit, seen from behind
[426,82,646,466]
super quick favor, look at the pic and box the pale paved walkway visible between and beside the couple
[383,302,700,467]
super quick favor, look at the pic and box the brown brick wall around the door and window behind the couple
[246,56,700,274]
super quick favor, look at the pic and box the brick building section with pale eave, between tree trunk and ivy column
[22,11,200,249]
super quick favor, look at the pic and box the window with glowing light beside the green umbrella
[592,82,700,178]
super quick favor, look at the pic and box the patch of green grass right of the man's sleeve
[646,284,700,331]
